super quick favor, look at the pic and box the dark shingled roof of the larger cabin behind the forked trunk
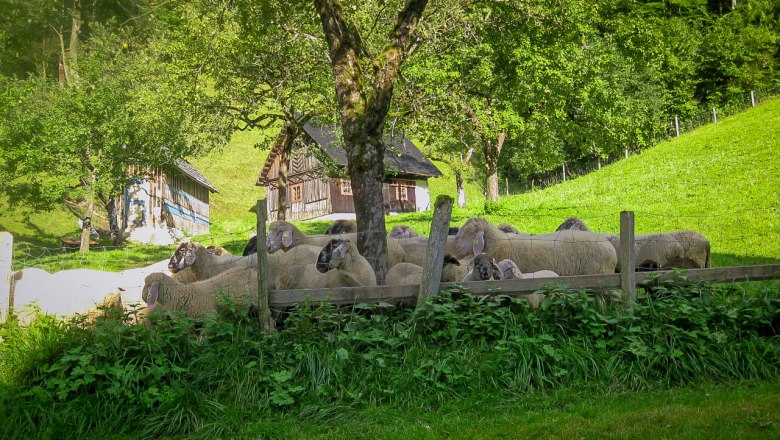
[303,124,442,177]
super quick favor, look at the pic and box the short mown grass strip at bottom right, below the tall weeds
[244,382,780,440]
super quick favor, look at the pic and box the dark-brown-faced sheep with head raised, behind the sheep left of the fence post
[168,242,257,283]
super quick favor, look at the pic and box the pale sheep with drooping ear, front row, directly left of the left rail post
[142,267,257,318]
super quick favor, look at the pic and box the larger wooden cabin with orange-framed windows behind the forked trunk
[257,124,442,221]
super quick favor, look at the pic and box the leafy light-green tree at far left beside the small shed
[0,26,229,251]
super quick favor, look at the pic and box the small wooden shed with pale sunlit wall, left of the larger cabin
[120,160,218,244]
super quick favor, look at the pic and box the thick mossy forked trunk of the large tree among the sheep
[314,0,428,283]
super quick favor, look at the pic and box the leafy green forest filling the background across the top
[0,0,780,223]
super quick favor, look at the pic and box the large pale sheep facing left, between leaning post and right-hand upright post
[455,218,617,276]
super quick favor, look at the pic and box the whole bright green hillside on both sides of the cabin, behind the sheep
[0,100,780,266]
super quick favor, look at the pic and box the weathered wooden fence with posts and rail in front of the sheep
[0,196,780,324]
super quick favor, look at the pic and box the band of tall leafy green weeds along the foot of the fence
[0,284,780,438]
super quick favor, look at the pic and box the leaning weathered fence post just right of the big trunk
[417,194,454,307]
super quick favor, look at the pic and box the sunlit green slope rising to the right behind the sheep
[391,100,780,266]
